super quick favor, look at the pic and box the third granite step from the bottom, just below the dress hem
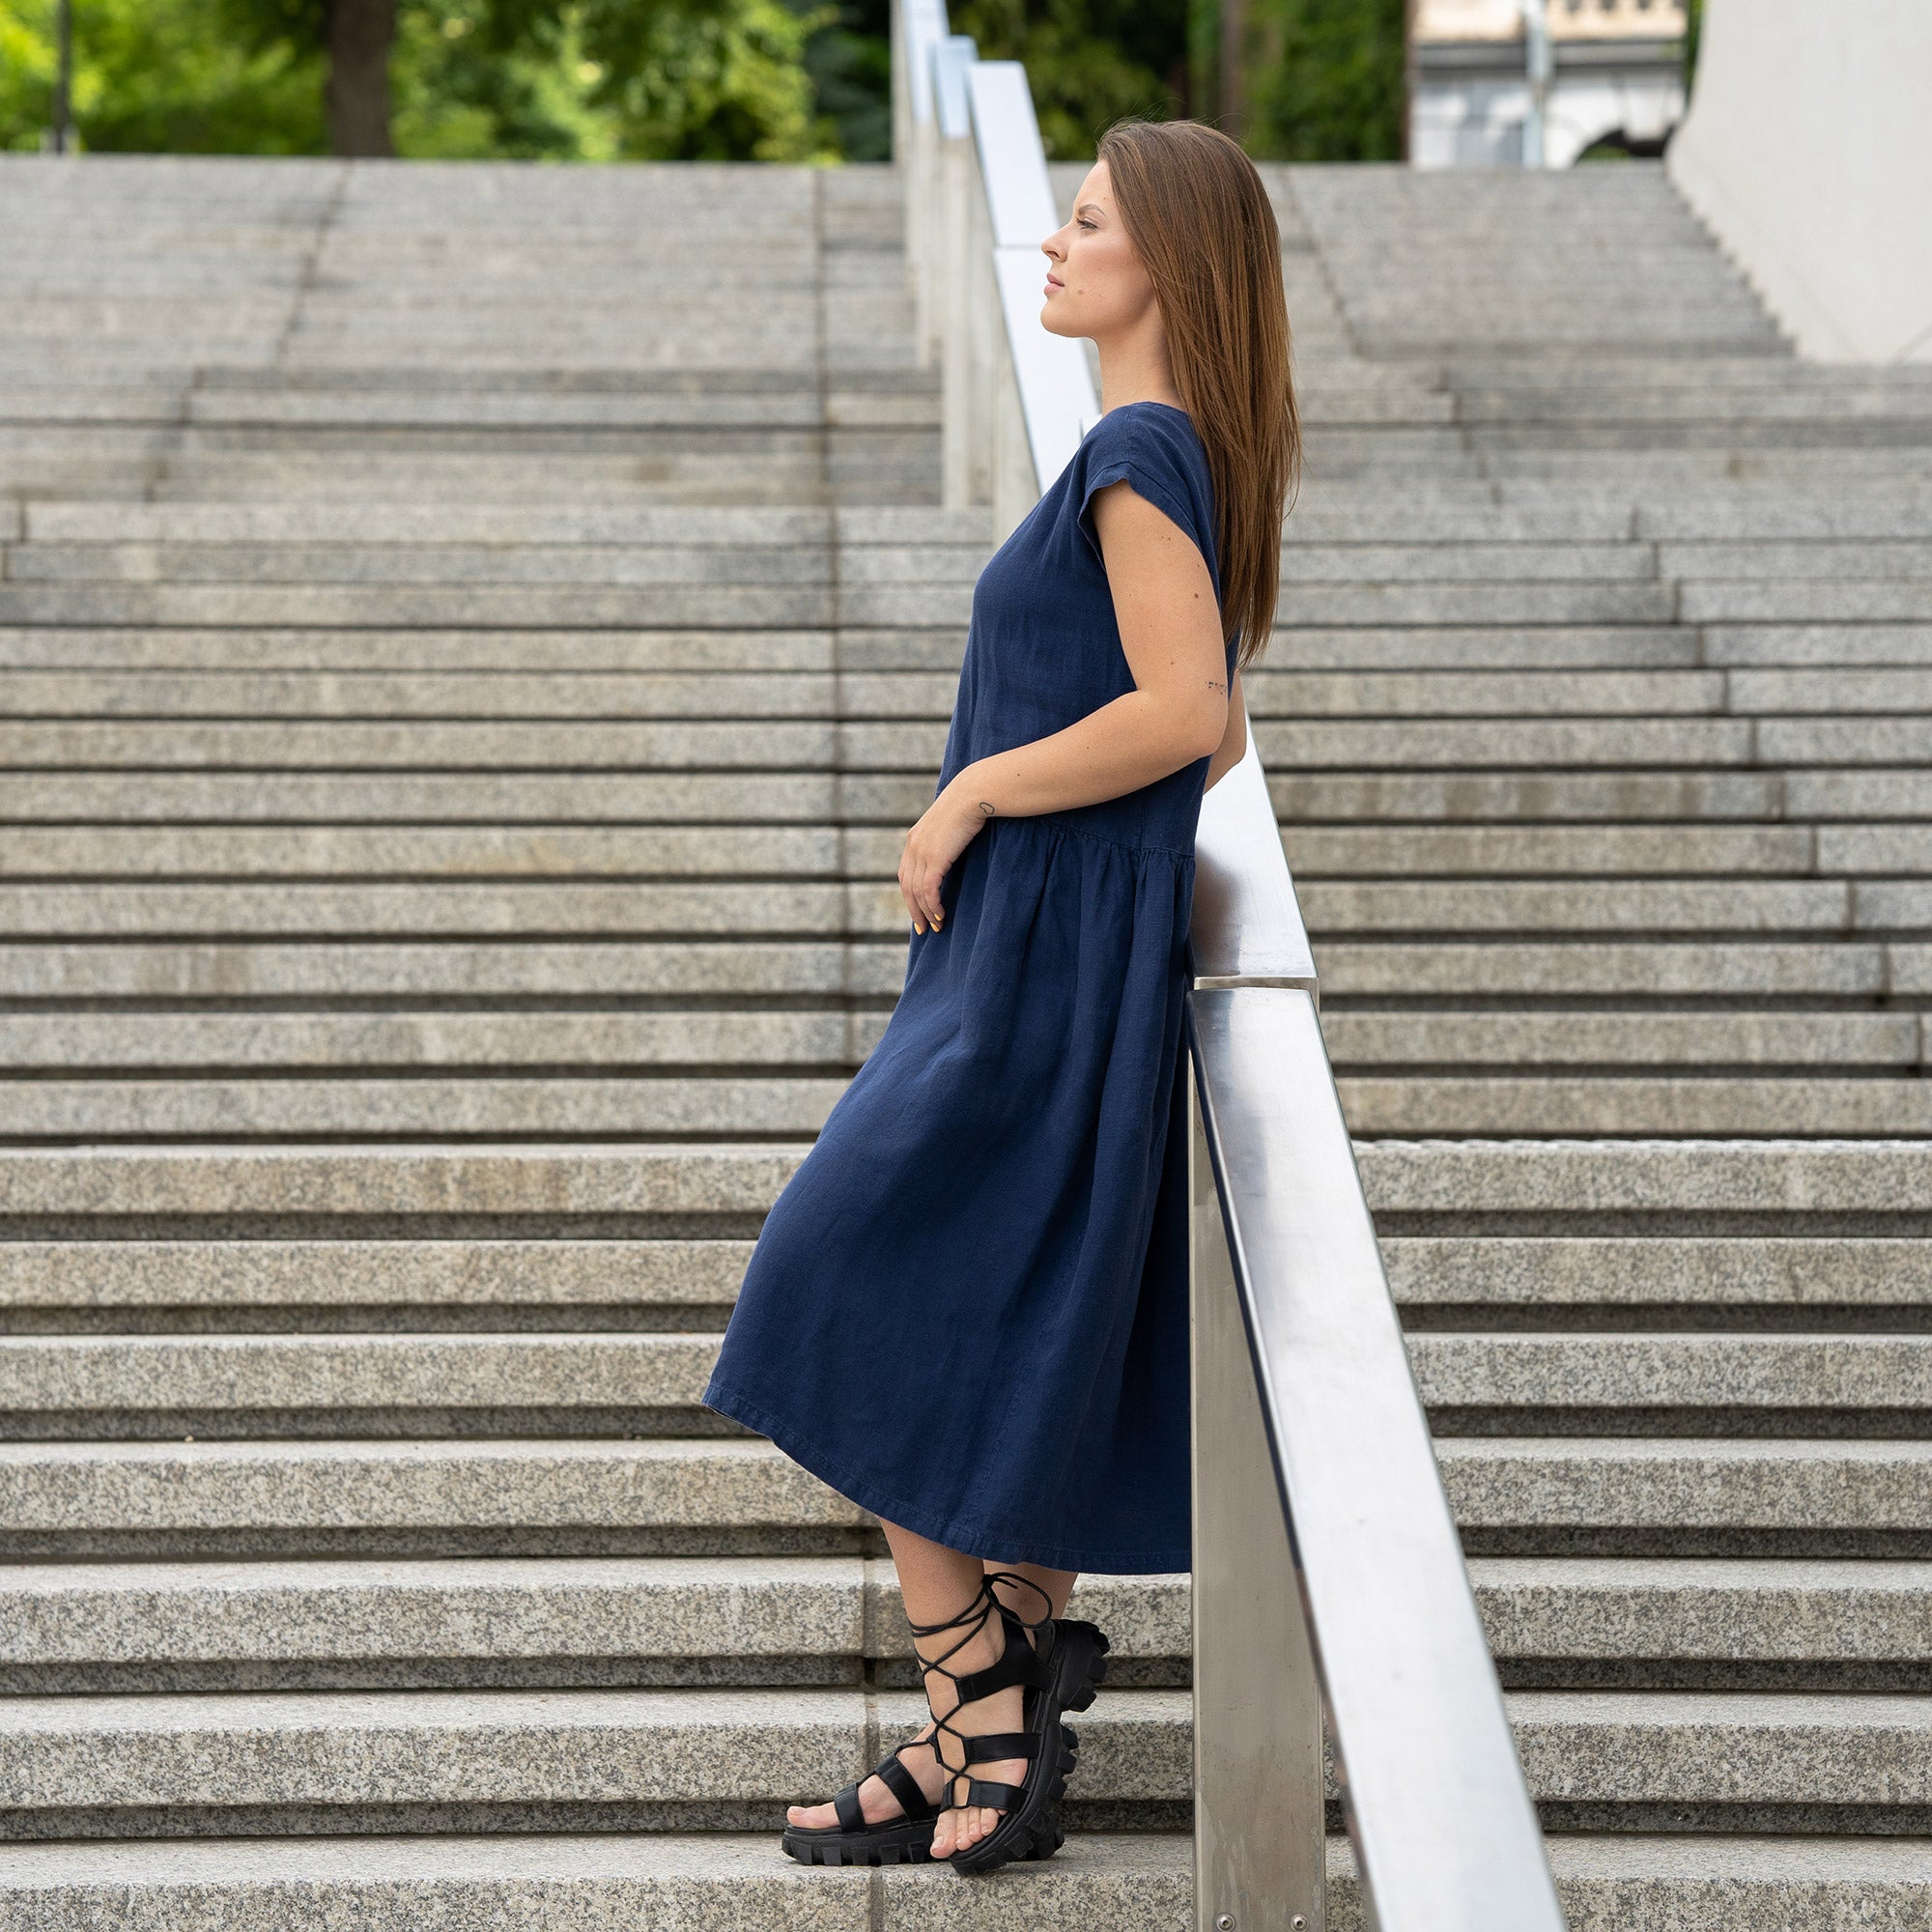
[0,1555,1932,1694]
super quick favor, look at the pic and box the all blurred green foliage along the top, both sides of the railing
[0,0,1403,160]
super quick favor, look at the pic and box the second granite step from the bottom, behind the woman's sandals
[0,1689,1932,1839]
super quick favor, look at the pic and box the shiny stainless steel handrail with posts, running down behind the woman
[893,18,1563,1932]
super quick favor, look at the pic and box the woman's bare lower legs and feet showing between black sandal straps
[786,1522,1076,1859]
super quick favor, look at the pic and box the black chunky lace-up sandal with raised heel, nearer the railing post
[912,1571,1107,1872]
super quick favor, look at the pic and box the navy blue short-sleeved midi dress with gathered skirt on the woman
[703,402,1235,1573]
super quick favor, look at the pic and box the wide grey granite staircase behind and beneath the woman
[0,156,1932,1932]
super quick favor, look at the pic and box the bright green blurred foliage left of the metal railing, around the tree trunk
[0,0,842,160]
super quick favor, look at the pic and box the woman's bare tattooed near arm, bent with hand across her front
[898,483,1229,931]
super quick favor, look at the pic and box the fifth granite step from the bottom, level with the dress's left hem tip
[0,1331,1932,1439]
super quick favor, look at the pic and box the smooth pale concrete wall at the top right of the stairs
[1667,0,1932,363]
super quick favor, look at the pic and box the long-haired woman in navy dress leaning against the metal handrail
[705,122,1298,1872]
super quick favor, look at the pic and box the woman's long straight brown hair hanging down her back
[1099,122,1302,668]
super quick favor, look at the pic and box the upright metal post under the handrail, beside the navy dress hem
[1180,1043,1327,1932]
